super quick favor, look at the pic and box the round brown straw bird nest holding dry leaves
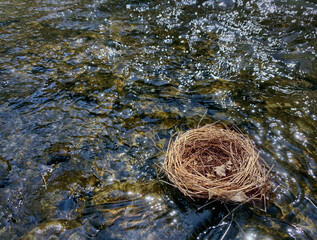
[163,125,270,203]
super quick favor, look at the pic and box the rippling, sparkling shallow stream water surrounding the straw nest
[0,0,317,240]
